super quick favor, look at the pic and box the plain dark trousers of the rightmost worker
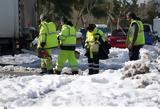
[129,45,142,61]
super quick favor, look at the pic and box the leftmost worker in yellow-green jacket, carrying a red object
[37,14,58,74]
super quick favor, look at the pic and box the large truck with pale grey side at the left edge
[0,0,37,55]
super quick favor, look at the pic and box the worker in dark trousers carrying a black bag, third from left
[85,24,106,75]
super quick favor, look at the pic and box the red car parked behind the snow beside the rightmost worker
[107,29,128,48]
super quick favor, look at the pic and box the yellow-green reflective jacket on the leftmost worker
[37,22,58,49]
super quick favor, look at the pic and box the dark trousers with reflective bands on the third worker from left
[88,53,99,75]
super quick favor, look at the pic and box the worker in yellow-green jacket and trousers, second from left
[55,17,78,74]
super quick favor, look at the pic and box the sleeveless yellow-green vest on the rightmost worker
[127,20,145,45]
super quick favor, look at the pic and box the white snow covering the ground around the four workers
[0,43,160,107]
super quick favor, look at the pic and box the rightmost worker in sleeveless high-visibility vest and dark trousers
[127,12,145,60]
